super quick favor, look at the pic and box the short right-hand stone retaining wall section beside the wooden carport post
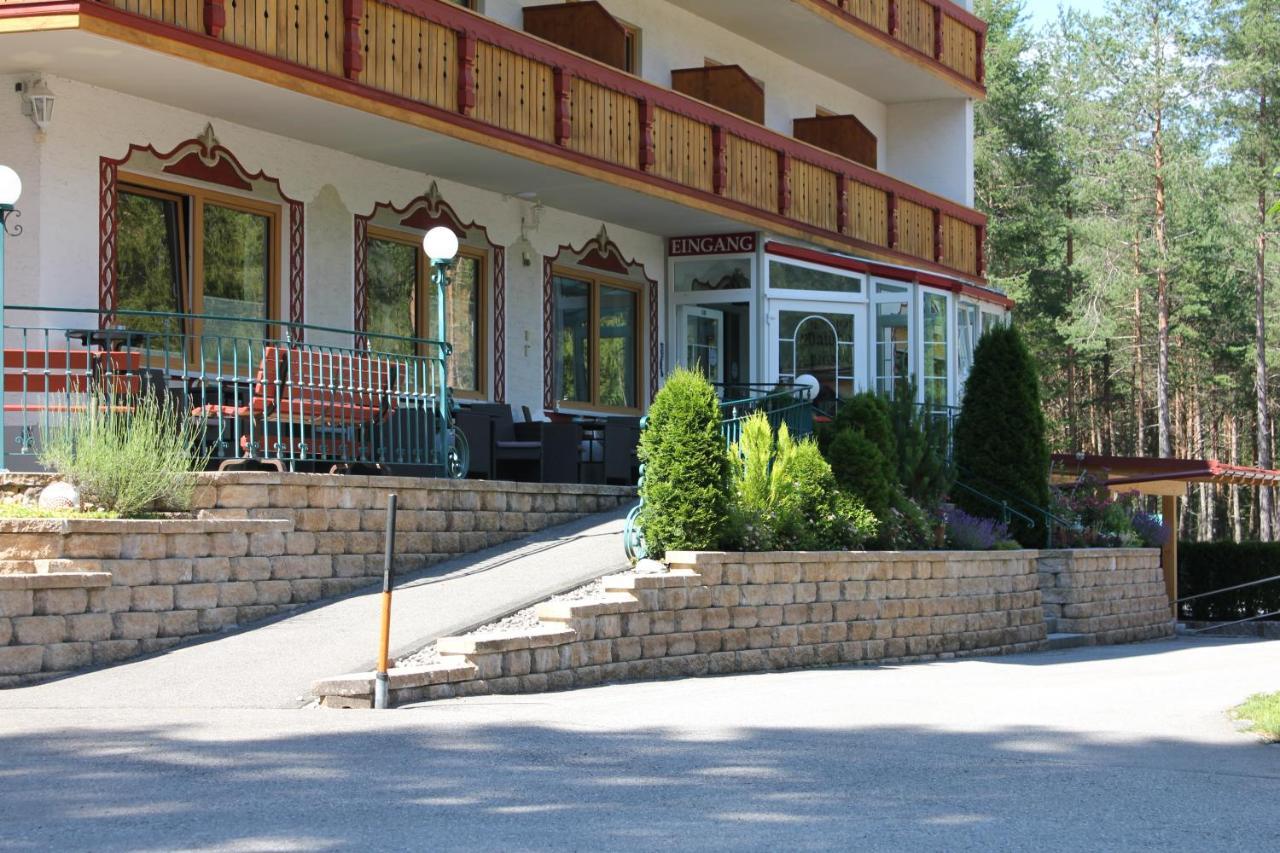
[1038,548,1174,644]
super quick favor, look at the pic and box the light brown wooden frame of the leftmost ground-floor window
[116,172,284,346]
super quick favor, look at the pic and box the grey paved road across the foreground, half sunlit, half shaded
[0,639,1280,853]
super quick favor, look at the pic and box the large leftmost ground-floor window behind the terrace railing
[116,178,279,359]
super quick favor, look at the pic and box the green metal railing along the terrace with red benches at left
[4,305,465,475]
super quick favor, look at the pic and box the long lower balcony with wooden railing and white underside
[0,0,986,279]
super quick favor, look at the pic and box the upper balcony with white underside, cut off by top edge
[672,0,987,102]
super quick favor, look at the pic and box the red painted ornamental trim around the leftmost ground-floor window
[97,124,306,330]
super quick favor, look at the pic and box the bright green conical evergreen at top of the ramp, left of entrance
[637,369,728,557]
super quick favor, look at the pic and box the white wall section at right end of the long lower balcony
[881,99,973,207]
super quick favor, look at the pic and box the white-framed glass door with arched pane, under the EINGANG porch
[769,302,867,403]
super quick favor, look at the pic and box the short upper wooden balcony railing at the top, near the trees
[806,0,987,86]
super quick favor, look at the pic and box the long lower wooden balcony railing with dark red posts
[57,0,986,278]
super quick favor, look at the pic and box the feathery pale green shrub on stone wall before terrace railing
[40,392,209,516]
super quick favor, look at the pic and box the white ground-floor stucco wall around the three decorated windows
[0,77,664,411]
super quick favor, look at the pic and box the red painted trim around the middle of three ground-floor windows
[353,181,507,402]
